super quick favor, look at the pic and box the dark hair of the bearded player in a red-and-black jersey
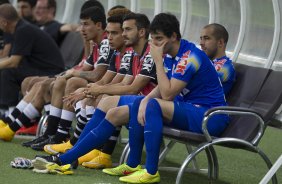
[123,12,150,38]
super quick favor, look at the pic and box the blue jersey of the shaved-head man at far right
[212,56,236,95]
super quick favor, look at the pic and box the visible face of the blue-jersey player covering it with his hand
[151,31,172,54]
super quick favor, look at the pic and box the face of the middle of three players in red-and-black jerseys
[106,22,124,50]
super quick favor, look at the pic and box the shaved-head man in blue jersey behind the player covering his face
[200,23,236,95]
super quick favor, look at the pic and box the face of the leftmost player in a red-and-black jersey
[80,18,97,41]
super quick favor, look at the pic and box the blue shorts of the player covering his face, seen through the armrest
[169,101,229,136]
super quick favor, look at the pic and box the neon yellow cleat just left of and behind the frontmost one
[103,164,142,176]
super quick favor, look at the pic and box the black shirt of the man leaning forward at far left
[11,20,64,74]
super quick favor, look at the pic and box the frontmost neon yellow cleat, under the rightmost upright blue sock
[119,169,161,183]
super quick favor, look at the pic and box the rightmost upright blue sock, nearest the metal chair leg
[144,99,163,174]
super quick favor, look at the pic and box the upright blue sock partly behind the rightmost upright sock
[126,98,144,168]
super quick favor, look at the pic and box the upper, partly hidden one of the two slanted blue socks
[76,108,106,144]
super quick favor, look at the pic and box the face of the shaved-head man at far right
[200,27,219,59]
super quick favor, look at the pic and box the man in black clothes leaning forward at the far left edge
[0,4,64,139]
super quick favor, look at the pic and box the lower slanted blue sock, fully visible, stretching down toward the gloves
[59,119,116,165]
